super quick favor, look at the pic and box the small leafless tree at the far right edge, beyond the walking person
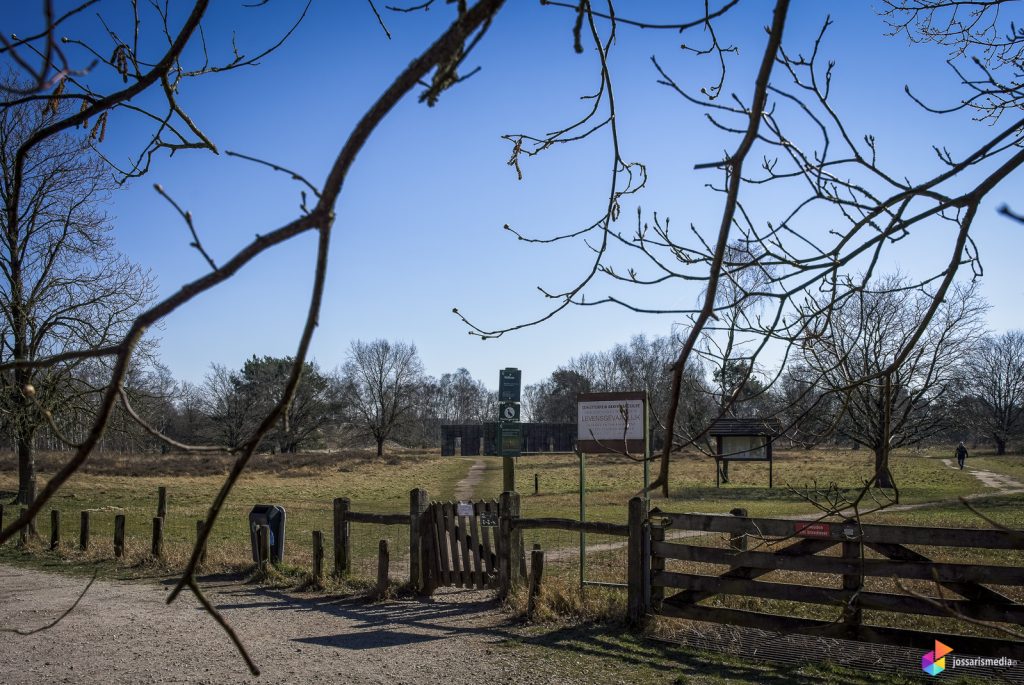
[969,331,1024,455]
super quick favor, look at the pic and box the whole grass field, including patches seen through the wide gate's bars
[0,451,1024,682]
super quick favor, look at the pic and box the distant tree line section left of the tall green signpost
[12,340,497,456]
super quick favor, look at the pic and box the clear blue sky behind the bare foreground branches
[4,0,1024,386]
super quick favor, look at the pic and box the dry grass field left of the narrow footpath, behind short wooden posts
[0,454,470,576]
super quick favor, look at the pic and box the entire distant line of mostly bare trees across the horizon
[18,294,1024,471]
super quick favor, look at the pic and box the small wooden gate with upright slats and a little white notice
[424,500,499,590]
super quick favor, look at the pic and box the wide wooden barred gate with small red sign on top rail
[630,509,1024,660]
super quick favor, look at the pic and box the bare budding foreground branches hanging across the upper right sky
[457,0,1024,495]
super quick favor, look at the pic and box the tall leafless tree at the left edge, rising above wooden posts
[0,78,153,504]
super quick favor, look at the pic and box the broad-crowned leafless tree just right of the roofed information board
[801,276,986,487]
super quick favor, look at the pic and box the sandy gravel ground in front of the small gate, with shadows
[0,565,544,685]
